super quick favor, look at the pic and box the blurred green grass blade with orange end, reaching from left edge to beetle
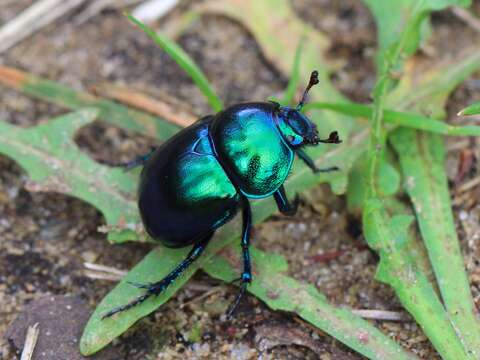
[0,65,180,140]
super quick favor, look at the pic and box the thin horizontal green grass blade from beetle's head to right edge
[305,102,480,136]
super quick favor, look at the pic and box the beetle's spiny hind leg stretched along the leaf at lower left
[102,231,213,319]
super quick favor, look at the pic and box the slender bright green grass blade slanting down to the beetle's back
[126,14,223,112]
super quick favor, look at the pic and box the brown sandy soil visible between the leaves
[0,0,480,359]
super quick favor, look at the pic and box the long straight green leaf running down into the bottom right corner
[390,129,480,358]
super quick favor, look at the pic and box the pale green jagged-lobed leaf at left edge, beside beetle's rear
[0,109,139,241]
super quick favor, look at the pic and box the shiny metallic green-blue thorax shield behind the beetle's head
[212,103,294,198]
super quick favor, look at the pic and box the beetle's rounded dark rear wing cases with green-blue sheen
[139,121,239,247]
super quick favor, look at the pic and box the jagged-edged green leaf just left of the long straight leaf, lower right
[363,198,475,360]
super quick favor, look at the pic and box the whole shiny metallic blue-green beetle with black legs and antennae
[103,71,341,318]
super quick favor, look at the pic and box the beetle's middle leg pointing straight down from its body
[227,196,252,318]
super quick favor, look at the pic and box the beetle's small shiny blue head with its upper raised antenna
[278,71,320,147]
